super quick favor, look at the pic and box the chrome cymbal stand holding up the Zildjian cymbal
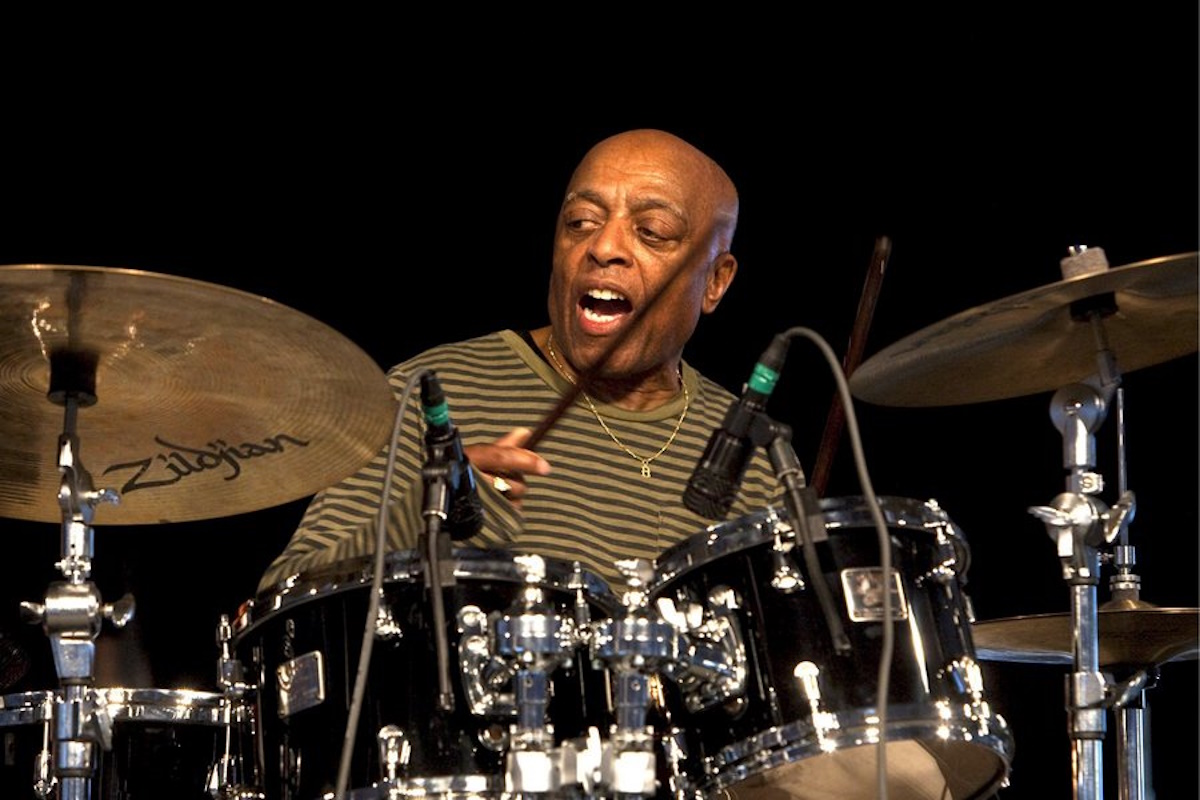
[22,350,133,800]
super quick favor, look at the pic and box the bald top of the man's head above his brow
[568,128,738,252]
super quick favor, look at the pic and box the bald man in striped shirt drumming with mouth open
[259,130,780,590]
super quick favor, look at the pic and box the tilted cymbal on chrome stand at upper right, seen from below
[848,253,1198,407]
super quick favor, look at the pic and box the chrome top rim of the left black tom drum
[234,547,622,637]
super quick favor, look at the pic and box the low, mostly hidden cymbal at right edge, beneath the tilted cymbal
[971,604,1200,667]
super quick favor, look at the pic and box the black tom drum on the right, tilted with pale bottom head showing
[652,497,1013,800]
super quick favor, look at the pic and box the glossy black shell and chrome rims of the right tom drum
[650,498,1012,798]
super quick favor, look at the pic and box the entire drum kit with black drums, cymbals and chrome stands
[0,248,1200,800]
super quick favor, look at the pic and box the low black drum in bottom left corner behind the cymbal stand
[0,688,244,800]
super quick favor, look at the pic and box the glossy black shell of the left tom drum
[234,548,619,800]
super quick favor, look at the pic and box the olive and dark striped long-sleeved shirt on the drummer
[259,330,782,593]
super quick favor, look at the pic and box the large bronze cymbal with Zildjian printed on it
[0,264,395,524]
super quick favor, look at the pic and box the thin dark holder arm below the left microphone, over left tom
[421,457,455,711]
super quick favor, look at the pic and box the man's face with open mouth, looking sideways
[548,137,732,378]
